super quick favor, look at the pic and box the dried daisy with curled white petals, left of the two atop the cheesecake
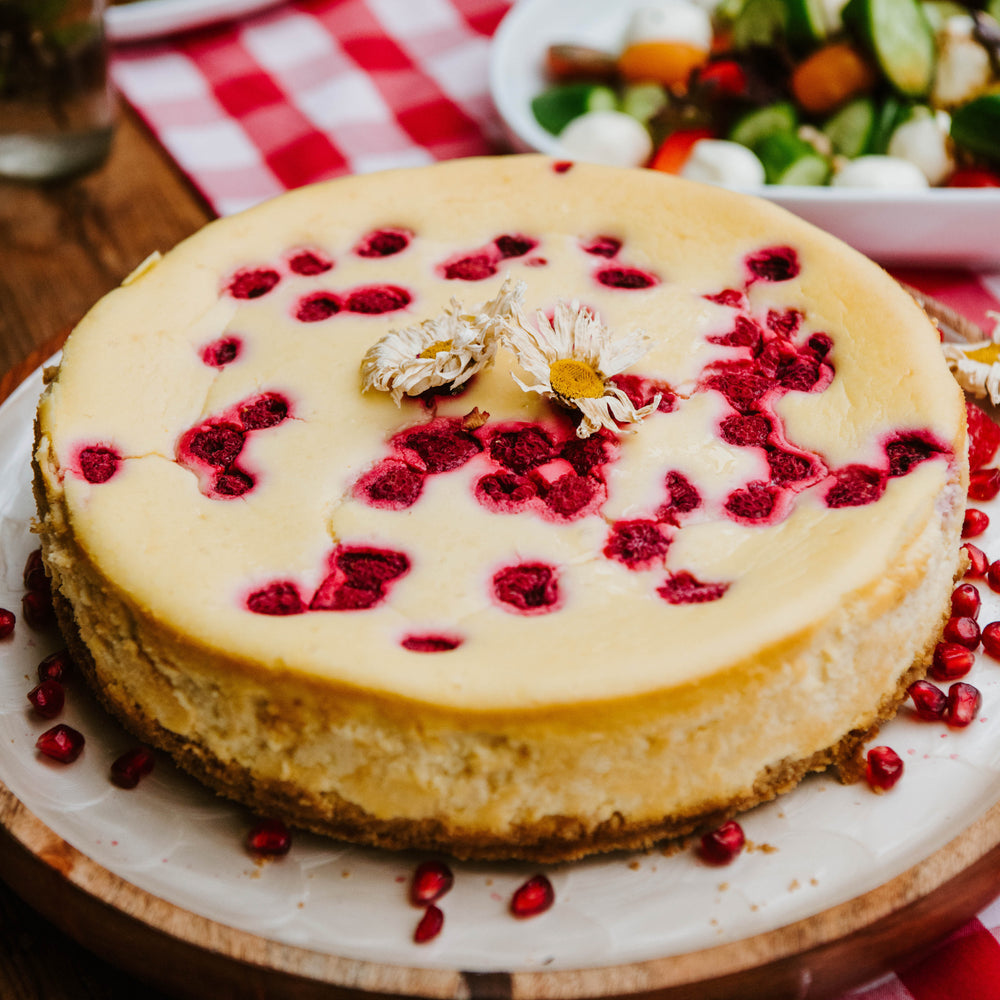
[361,281,523,406]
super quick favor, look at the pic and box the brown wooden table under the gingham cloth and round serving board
[0,110,212,1000]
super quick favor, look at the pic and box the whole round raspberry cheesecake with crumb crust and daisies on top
[35,156,967,860]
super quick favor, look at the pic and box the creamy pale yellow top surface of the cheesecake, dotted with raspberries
[38,156,964,714]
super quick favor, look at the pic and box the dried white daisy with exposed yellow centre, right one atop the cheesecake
[504,301,660,438]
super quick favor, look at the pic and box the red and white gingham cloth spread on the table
[112,0,1000,1000]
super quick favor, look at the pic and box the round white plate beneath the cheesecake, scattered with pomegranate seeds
[0,360,1000,972]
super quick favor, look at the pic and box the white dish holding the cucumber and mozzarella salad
[490,0,1000,269]
